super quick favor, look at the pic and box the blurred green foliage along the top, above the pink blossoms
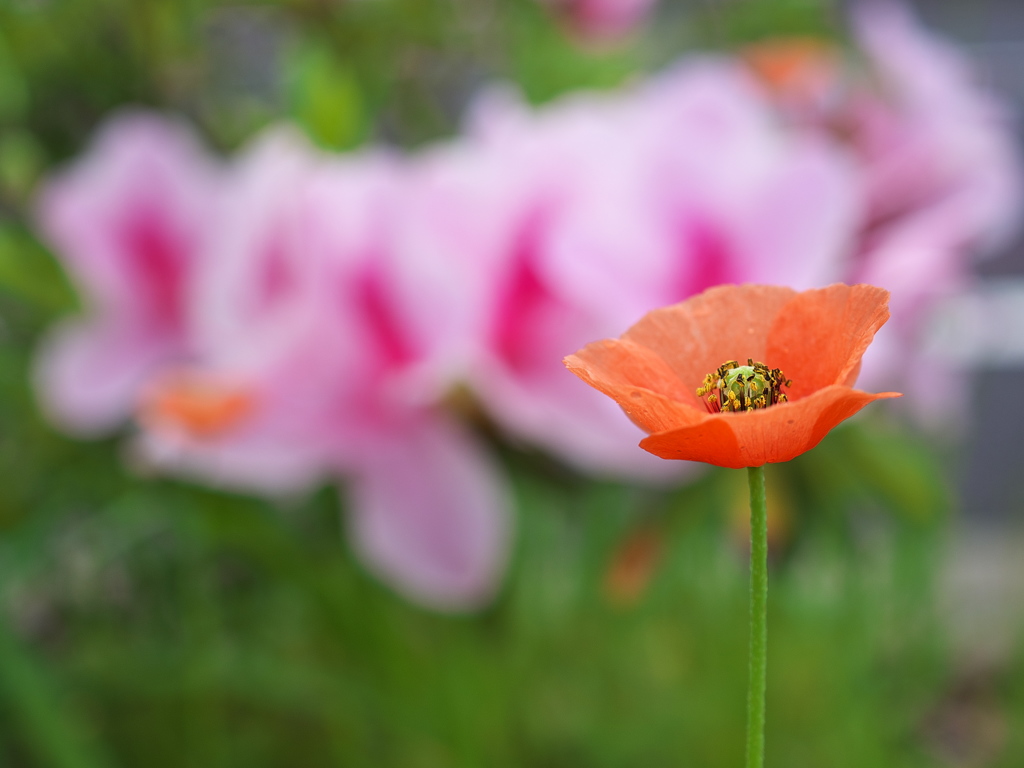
[0,0,839,162]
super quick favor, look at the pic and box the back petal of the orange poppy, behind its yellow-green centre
[623,285,798,403]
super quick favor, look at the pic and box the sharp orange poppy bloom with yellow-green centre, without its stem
[565,284,900,468]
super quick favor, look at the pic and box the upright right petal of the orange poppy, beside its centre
[763,284,889,400]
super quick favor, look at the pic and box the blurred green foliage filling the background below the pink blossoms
[0,415,958,768]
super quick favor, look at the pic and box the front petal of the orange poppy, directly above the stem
[640,385,900,468]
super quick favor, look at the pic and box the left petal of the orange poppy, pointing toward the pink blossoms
[564,339,705,432]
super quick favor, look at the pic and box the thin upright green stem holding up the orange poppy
[746,467,768,768]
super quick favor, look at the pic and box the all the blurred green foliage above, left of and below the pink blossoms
[0,0,1024,768]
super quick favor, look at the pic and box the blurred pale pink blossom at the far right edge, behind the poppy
[852,3,1021,418]
